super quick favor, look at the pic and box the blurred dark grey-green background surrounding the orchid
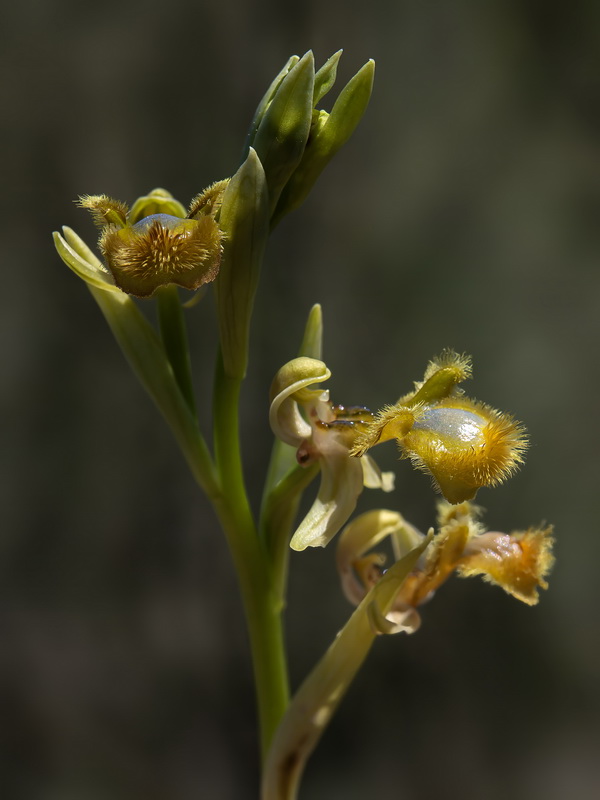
[0,0,600,800]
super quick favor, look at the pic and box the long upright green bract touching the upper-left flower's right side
[215,148,269,378]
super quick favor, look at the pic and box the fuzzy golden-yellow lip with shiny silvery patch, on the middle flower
[352,351,527,503]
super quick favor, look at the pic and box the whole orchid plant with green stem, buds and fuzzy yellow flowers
[54,51,552,800]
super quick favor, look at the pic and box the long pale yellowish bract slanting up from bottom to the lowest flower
[261,536,431,800]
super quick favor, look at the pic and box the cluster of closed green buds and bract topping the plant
[215,50,374,377]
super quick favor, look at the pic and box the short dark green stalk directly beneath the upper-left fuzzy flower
[156,285,195,413]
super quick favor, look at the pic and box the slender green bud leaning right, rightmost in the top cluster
[272,60,375,225]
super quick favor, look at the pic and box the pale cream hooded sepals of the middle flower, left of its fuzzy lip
[269,357,394,550]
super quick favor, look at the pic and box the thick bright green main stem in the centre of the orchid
[213,353,289,759]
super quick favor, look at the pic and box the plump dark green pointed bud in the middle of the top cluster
[253,51,315,211]
